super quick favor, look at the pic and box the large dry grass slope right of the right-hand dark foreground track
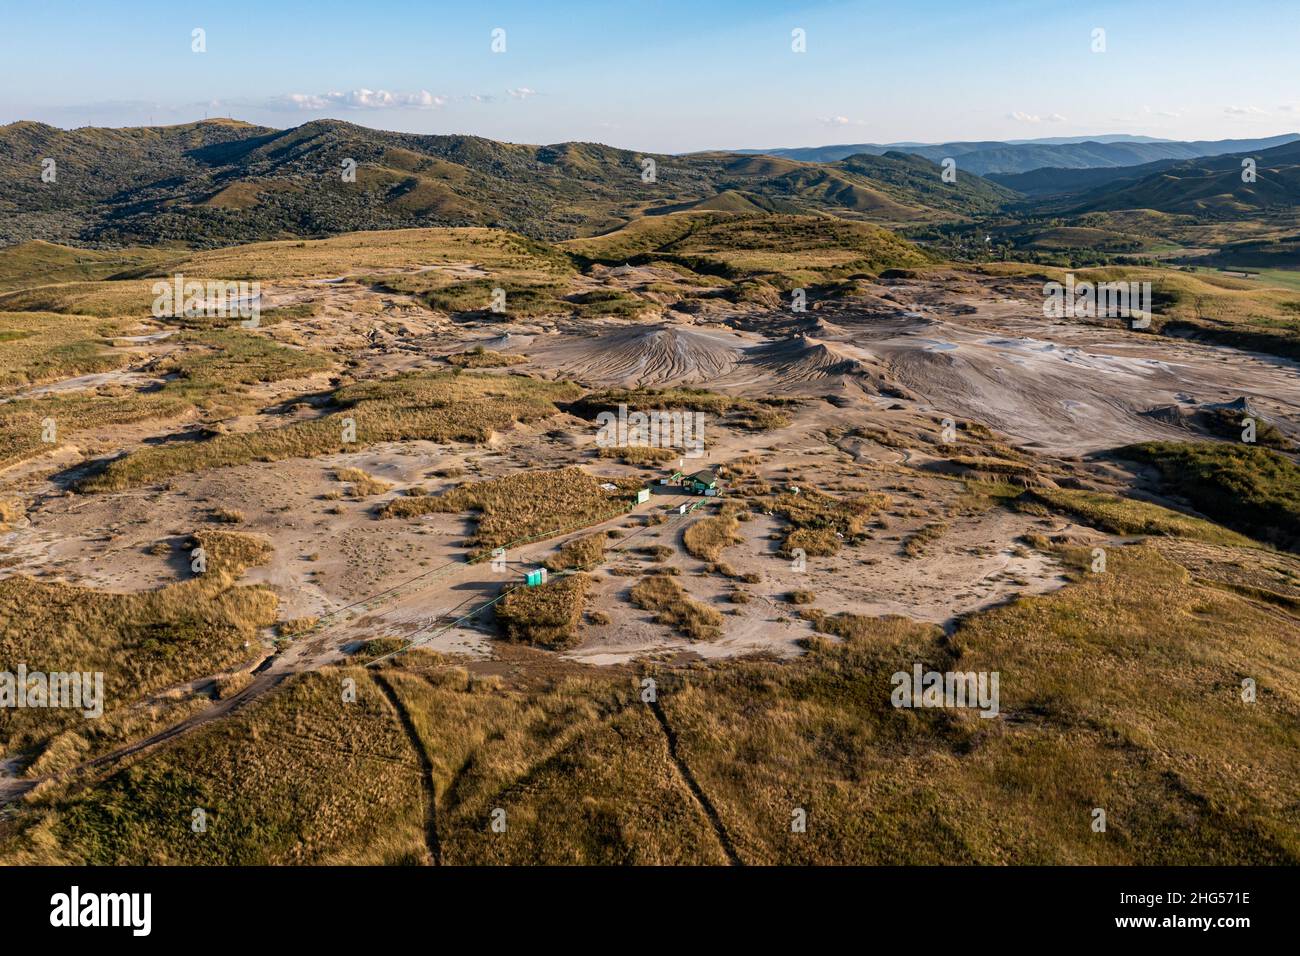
[663,549,1300,865]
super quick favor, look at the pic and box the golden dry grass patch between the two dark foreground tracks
[366,669,727,865]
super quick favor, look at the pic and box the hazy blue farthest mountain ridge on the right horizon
[740,133,1300,176]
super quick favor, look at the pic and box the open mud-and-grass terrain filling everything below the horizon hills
[0,211,1300,864]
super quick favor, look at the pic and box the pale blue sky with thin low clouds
[0,0,1300,152]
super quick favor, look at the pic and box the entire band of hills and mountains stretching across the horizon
[0,120,1300,246]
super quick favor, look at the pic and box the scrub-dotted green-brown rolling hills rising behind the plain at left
[0,120,1015,246]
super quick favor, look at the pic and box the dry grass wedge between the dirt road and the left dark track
[0,669,425,865]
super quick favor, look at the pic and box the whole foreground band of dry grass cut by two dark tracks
[10,540,1300,865]
